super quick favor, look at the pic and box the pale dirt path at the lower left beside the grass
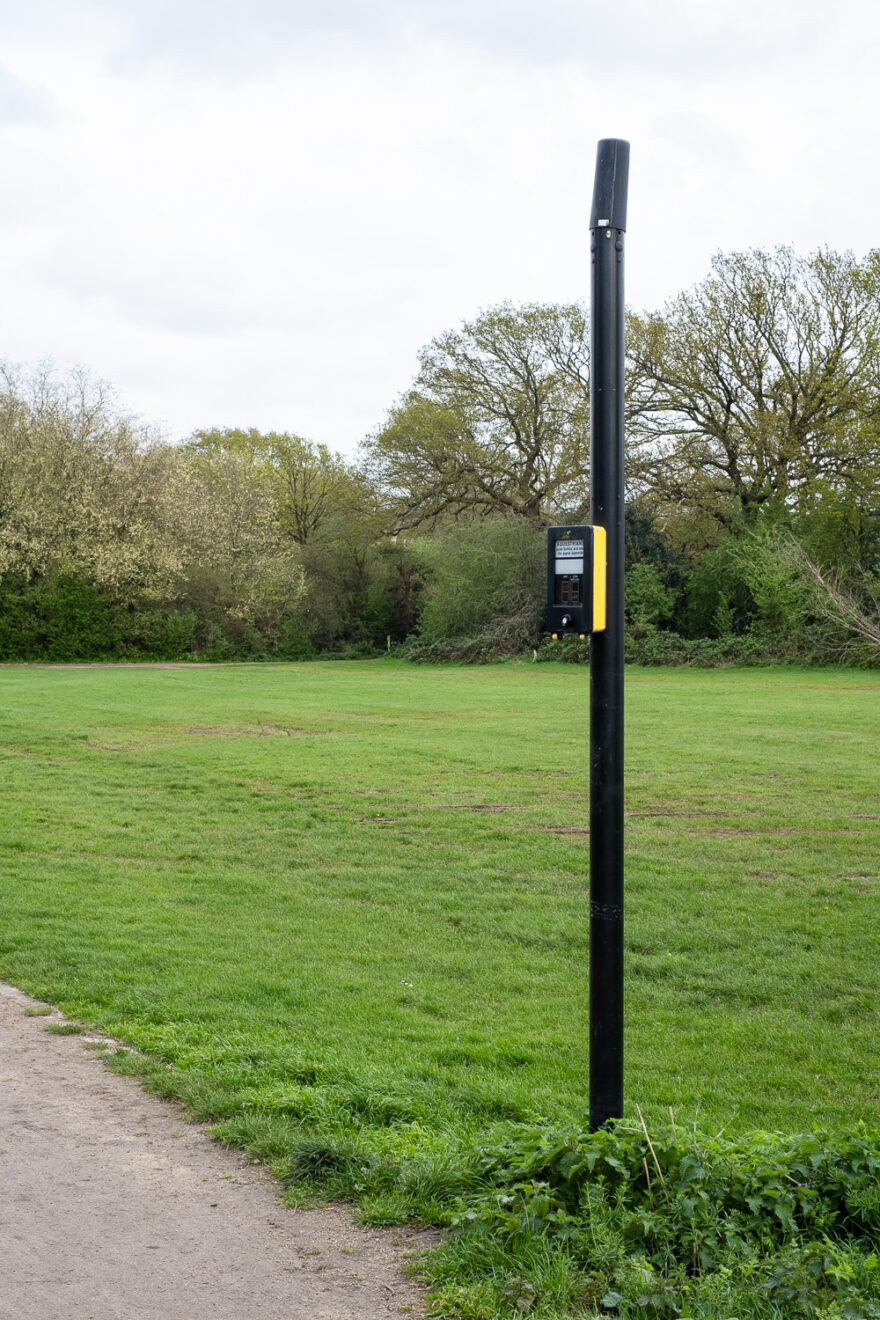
[0,983,427,1320]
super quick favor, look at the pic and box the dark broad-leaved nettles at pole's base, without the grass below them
[460,1125,880,1251]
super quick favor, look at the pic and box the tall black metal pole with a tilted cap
[590,137,629,1131]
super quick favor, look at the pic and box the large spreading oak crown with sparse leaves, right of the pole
[628,248,880,527]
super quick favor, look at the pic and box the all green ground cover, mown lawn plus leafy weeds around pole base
[6,660,880,1320]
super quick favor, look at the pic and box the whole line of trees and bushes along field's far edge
[0,248,880,663]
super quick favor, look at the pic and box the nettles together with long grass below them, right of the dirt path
[429,1126,880,1320]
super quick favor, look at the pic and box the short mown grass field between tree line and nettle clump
[0,660,880,1313]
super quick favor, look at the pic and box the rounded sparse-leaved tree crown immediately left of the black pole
[365,302,588,529]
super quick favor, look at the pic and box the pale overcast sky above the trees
[0,0,880,453]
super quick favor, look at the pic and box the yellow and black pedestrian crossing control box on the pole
[548,527,606,642]
